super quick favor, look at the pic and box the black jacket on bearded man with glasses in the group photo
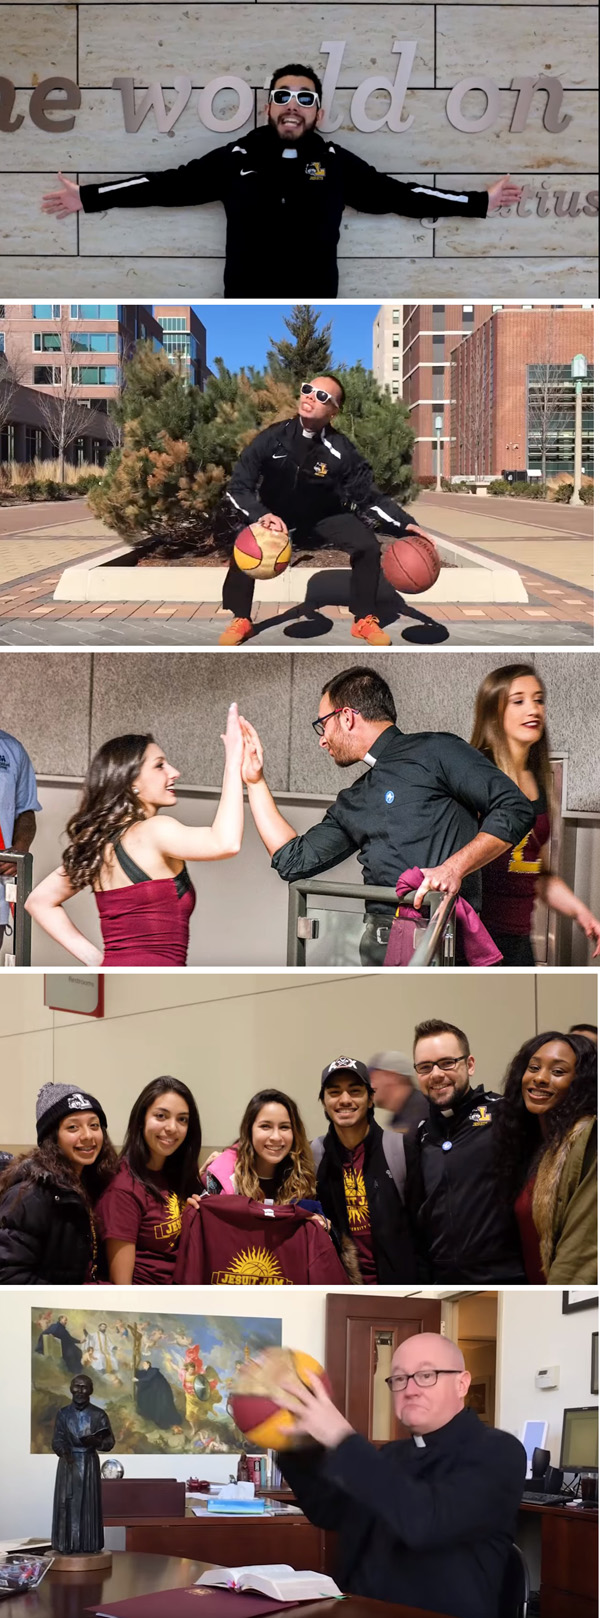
[404,1084,526,1286]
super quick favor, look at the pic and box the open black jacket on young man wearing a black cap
[317,1118,417,1286]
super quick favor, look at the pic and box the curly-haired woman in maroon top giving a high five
[27,702,244,966]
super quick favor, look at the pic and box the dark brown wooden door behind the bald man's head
[325,1291,442,1443]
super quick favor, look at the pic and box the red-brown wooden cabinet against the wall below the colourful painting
[103,1513,328,1572]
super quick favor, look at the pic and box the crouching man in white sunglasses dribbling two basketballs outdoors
[217,375,422,646]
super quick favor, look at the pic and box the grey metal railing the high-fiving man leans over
[288,880,458,968]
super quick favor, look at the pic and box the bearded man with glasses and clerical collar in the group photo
[404,1018,526,1286]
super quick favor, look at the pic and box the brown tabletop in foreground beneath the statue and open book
[0,1550,456,1618]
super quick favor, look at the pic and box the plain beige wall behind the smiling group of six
[0,972,598,1149]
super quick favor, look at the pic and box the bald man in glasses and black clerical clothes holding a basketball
[278,1332,527,1618]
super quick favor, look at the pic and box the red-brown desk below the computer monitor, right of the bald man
[521,1502,598,1618]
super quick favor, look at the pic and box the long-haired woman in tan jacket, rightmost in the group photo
[496,1031,598,1286]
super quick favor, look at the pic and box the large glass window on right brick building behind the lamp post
[527,364,594,479]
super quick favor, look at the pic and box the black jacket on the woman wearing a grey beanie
[0,1158,94,1286]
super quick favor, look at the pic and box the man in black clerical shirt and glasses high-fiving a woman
[241,667,534,966]
